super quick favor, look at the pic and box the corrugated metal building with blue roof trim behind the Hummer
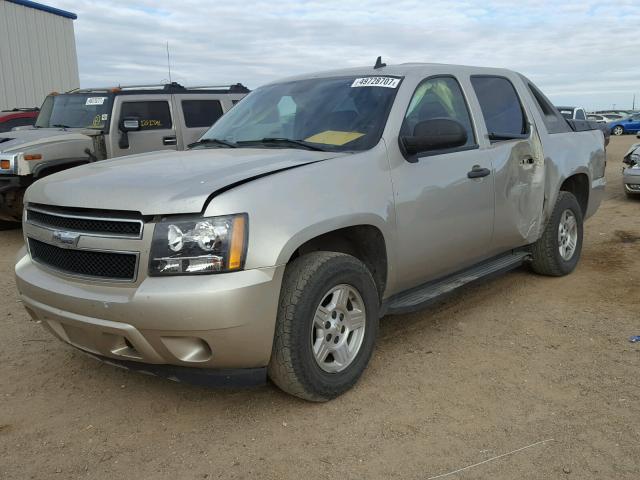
[0,0,80,110]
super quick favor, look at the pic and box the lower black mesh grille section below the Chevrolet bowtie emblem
[29,238,137,280]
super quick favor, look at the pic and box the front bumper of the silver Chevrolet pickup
[15,248,284,369]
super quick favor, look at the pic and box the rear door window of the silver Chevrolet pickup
[471,76,527,137]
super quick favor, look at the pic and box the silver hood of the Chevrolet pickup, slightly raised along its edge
[25,148,346,215]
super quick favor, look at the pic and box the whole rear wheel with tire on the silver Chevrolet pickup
[531,191,583,277]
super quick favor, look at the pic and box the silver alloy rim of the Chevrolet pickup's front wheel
[311,284,366,373]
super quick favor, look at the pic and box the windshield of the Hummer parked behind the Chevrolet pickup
[35,93,111,130]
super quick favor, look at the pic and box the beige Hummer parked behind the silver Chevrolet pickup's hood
[0,82,249,221]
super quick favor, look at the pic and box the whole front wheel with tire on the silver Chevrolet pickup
[268,252,380,402]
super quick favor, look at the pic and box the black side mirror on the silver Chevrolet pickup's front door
[400,118,467,161]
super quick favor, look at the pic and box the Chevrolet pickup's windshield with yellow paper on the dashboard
[200,77,400,151]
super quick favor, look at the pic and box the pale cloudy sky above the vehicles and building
[43,0,640,110]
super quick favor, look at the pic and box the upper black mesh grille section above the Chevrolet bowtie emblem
[27,209,142,238]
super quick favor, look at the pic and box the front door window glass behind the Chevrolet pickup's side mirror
[401,77,476,148]
